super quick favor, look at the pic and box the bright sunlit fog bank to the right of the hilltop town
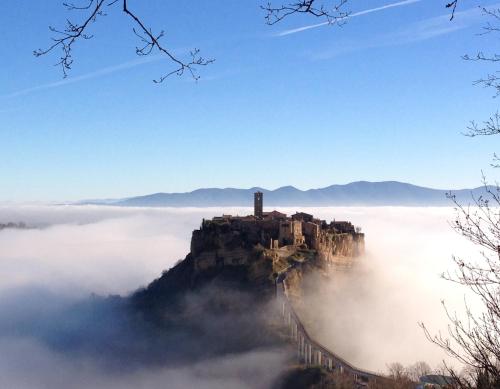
[286,208,478,371]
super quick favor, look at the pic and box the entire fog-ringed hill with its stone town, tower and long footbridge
[132,192,376,383]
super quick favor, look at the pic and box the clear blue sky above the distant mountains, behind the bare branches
[0,0,498,201]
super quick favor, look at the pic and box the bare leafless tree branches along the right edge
[422,4,500,389]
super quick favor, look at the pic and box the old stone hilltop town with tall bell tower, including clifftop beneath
[191,192,364,274]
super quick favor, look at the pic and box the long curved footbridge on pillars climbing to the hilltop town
[276,276,384,383]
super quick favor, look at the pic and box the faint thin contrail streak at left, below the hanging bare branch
[0,55,163,99]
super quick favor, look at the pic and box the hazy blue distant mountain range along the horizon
[79,181,492,207]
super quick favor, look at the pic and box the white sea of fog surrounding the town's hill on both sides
[0,205,478,389]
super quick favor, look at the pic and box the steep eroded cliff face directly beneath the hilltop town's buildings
[186,218,364,297]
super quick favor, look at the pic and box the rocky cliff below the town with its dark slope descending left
[135,214,364,312]
